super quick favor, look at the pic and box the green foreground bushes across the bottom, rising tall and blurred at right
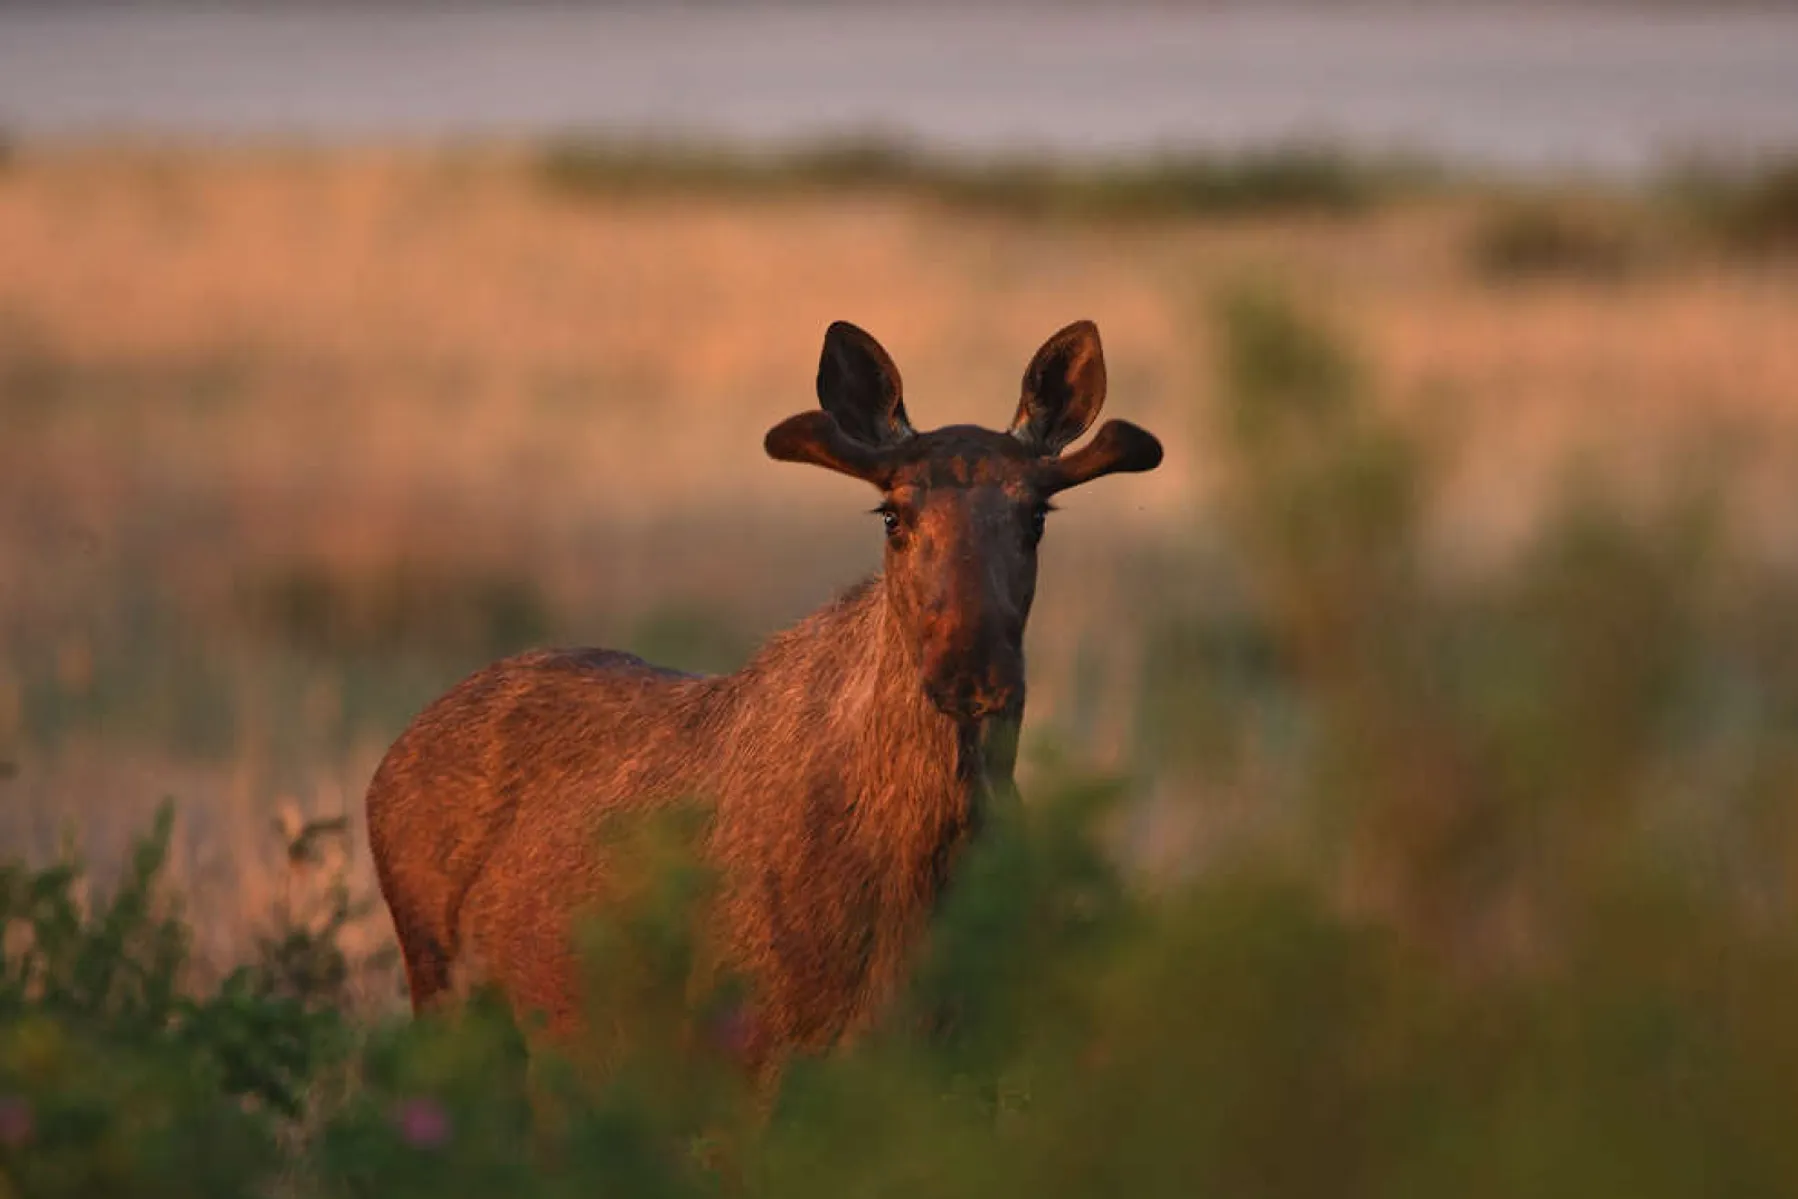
[0,291,1798,1199]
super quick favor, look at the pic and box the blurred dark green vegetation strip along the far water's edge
[530,137,1798,264]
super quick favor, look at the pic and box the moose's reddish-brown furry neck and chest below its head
[712,577,1016,1044]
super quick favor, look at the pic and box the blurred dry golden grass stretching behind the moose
[0,147,1798,999]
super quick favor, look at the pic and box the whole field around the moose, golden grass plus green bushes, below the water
[0,146,1798,1199]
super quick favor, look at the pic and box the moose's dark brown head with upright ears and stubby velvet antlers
[764,320,1162,723]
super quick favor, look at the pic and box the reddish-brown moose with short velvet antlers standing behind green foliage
[367,322,1162,1062]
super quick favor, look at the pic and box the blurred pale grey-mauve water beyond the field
[0,0,1798,174]
